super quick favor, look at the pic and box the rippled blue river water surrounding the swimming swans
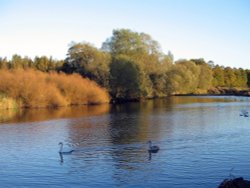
[0,97,250,188]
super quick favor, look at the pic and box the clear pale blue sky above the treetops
[0,0,250,69]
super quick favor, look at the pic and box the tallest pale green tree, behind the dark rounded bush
[102,29,173,98]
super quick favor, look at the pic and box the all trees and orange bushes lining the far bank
[0,29,250,109]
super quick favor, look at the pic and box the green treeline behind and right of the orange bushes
[0,29,250,100]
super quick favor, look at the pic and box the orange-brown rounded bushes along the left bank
[0,69,109,107]
